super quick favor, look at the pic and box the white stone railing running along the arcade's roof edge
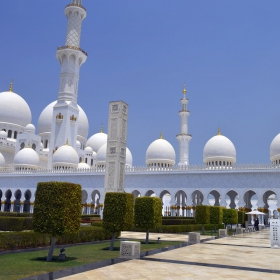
[0,164,280,175]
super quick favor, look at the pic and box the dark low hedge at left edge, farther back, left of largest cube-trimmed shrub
[0,216,32,231]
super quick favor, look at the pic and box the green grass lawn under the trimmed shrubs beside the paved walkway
[0,240,180,280]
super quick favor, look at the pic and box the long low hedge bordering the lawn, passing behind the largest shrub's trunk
[0,227,117,251]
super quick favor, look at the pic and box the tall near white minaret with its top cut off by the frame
[48,0,87,168]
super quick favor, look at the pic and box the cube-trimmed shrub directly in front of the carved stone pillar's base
[103,192,134,250]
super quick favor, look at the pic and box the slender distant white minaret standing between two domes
[176,84,192,165]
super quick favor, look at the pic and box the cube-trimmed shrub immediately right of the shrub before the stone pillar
[134,196,162,244]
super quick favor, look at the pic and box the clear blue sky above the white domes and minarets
[0,0,280,165]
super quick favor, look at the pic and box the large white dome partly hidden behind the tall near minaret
[38,101,88,138]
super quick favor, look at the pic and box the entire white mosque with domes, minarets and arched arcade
[0,0,280,219]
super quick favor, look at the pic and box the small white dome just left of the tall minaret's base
[14,147,40,169]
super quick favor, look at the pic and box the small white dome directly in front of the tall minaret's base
[53,144,79,168]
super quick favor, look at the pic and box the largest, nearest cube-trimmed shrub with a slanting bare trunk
[33,182,82,261]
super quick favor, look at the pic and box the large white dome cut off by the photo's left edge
[0,91,31,127]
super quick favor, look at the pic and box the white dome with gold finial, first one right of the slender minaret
[203,129,236,166]
